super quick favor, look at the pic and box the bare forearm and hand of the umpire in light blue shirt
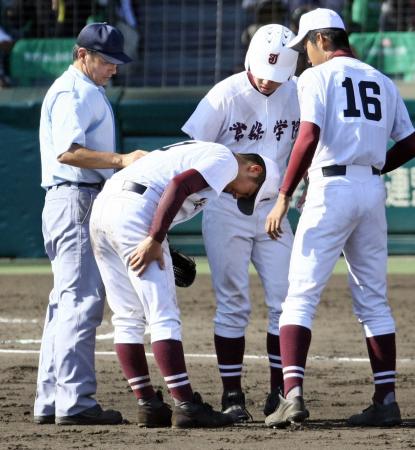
[58,144,148,169]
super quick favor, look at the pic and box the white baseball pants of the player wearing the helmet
[203,194,293,338]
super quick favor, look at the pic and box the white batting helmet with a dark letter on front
[245,24,298,83]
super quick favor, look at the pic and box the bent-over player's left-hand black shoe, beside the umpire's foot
[138,390,172,428]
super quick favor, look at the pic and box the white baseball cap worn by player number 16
[287,8,346,52]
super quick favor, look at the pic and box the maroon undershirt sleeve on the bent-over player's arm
[149,169,209,243]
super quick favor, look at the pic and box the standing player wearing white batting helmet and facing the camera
[182,24,300,421]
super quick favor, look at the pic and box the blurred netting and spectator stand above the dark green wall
[0,0,415,86]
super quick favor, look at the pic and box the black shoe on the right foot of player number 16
[347,402,402,427]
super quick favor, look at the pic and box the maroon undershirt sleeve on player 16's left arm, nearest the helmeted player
[280,122,320,197]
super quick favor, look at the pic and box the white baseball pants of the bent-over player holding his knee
[91,180,181,344]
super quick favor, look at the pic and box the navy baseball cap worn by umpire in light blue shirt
[76,22,132,64]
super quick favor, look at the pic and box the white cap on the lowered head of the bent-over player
[237,155,280,216]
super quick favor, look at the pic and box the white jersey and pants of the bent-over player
[91,141,272,343]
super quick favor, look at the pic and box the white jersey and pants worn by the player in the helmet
[182,72,299,338]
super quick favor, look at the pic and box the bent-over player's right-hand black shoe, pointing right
[171,392,234,428]
